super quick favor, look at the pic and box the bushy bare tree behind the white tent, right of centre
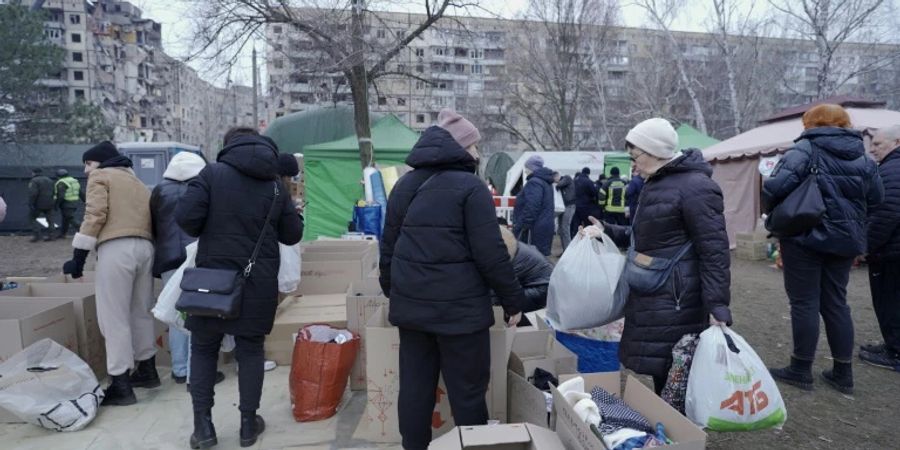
[497,0,617,150]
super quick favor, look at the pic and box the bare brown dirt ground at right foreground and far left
[0,237,900,449]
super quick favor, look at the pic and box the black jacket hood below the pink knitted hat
[406,127,478,174]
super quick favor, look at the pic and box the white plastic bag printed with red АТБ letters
[685,326,787,431]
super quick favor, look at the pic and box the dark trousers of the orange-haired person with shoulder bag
[781,239,853,362]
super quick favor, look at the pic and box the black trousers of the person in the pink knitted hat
[397,328,491,450]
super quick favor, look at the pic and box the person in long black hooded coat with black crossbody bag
[175,128,303,448]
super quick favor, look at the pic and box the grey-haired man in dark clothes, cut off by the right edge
[859,125,900,372]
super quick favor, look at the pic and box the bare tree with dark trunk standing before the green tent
[191,0,476,167]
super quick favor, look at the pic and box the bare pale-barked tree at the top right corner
[769,0,897,98]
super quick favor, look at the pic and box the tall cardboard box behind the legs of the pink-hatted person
[357,306,516,442]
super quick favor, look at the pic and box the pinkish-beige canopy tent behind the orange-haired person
[703,105,900,246]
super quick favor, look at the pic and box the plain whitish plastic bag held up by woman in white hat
[547,234,625,331]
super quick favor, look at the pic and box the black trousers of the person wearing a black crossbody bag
[191,330,266,413]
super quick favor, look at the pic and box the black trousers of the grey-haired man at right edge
[869,261,900,353]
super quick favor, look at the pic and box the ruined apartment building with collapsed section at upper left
[33,0,253,149]
